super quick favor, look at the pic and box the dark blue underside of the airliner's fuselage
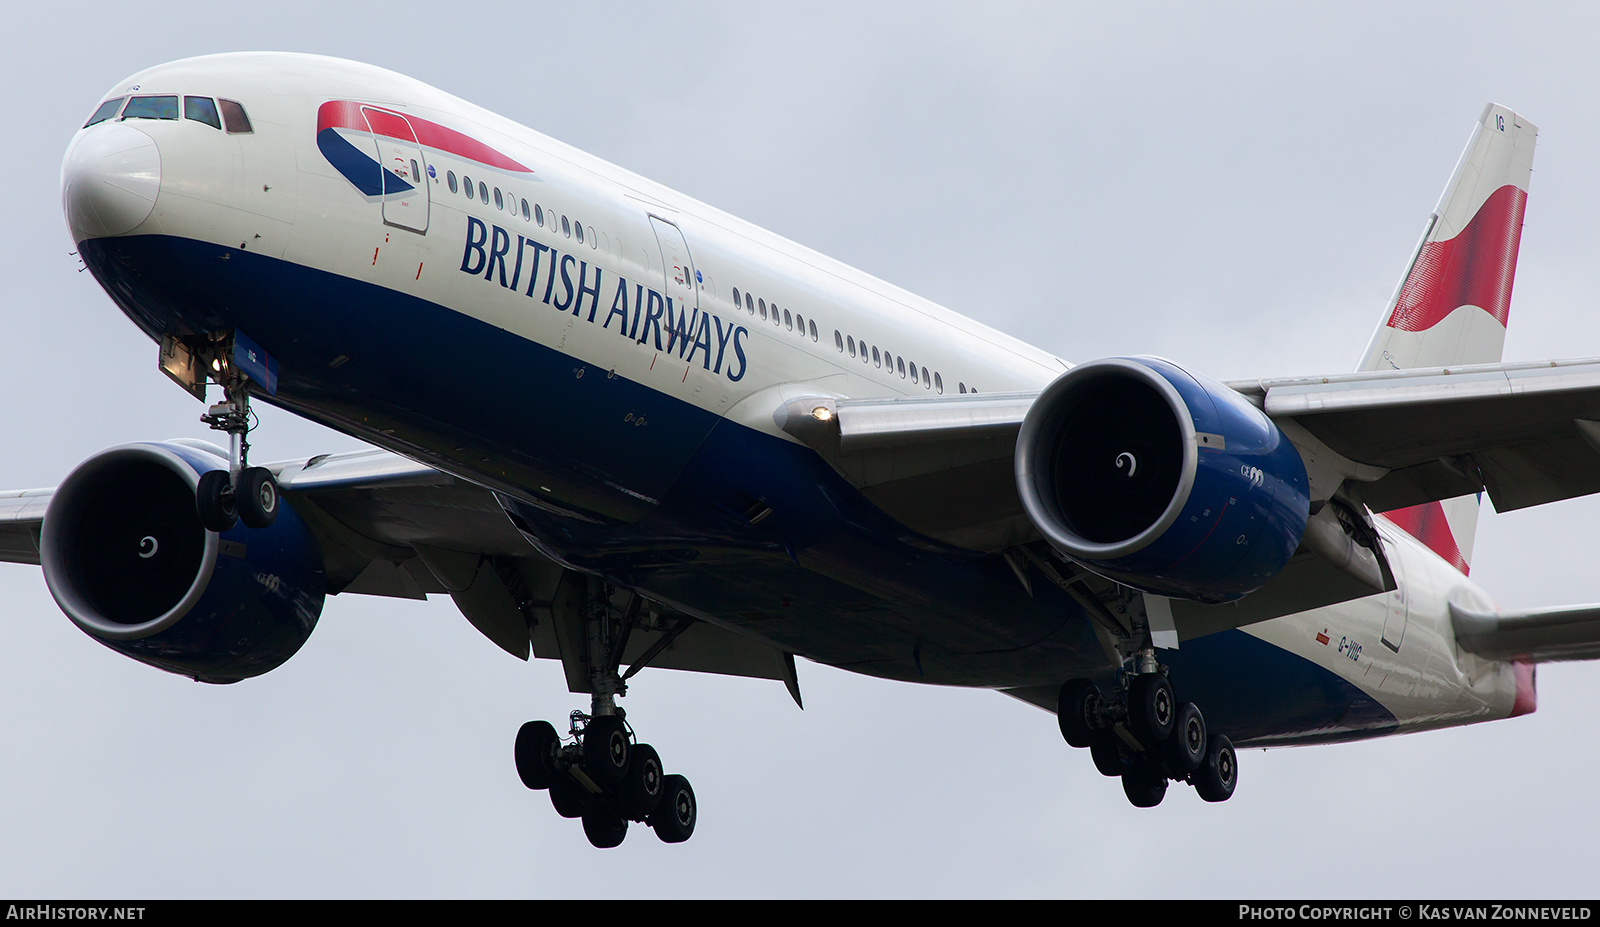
[80,235,1395,743]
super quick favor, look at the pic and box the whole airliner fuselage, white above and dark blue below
[62,54,1531,743]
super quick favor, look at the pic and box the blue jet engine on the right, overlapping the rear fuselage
[1016,357,1310,602]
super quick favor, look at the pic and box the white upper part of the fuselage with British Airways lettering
[64,54,1518,736]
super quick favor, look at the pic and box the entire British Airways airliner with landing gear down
[0,54,1600,847]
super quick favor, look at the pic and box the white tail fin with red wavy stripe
[1357,102,1539,573]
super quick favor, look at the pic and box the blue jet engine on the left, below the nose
[40,442,325,682]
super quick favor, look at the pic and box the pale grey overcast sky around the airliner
[0,2,1600,898]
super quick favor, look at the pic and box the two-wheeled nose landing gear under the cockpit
[195,362,278,533]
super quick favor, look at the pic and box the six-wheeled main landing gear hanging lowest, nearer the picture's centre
[517,578,698,849]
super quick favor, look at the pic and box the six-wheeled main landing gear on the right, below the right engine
[1056,653,1238,809]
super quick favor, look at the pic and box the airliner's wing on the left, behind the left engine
[0,442,798,700]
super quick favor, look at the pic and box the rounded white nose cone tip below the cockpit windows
[61,122,162,242]
